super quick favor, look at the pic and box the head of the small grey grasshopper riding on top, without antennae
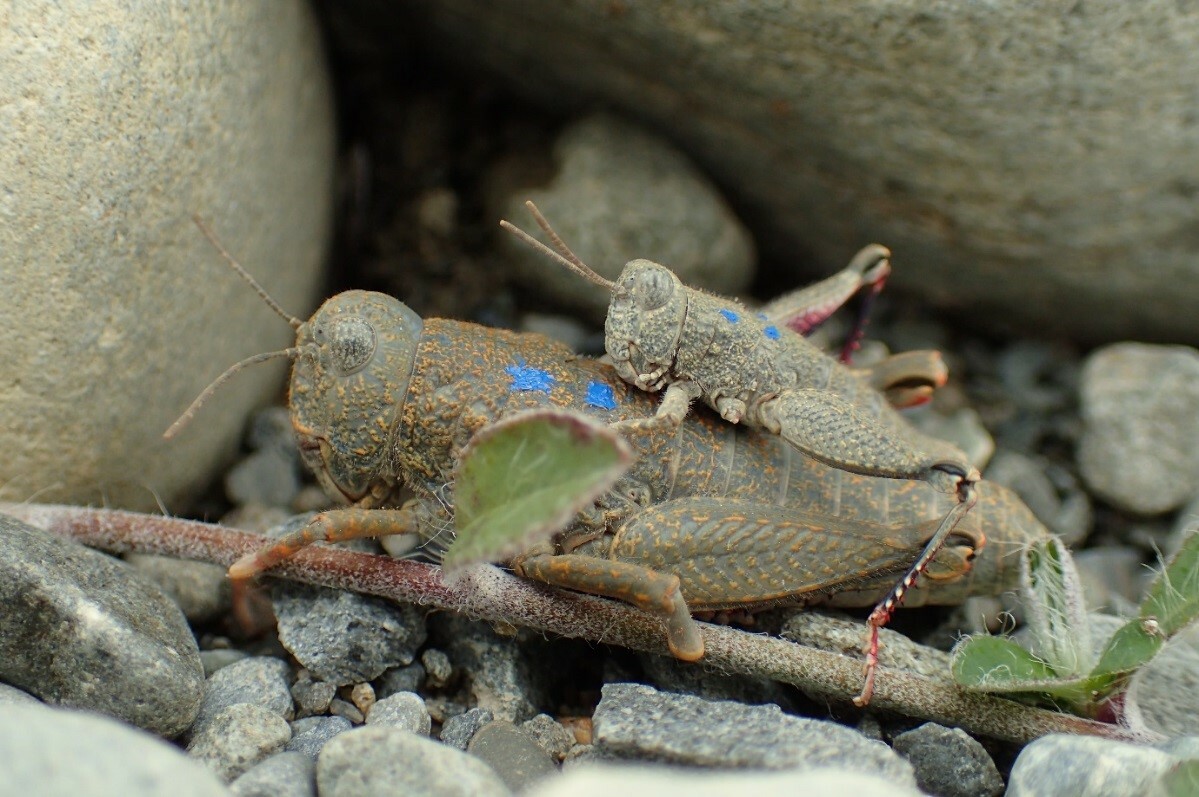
[604,260,687,390]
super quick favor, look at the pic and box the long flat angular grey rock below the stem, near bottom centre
[592,683,916,786]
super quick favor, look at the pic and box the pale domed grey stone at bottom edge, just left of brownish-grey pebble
[317,725,512,797]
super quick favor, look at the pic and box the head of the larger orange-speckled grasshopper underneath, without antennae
[289,290,423,502]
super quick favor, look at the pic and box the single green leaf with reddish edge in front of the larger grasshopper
[442,410,633,572]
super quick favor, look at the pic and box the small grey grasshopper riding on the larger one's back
[500,201,982,695]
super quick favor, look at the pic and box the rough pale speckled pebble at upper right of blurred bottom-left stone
[187,704,291,783]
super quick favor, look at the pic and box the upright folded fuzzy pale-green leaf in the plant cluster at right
[1022,537,1095,678]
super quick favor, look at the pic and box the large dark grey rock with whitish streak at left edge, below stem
[0,515,204,736]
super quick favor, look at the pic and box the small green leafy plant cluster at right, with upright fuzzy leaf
[953,530,1199,717]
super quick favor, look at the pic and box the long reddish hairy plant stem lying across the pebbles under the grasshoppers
[0,503,1151,743]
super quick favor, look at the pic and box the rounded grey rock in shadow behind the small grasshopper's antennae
[498,114,755,320]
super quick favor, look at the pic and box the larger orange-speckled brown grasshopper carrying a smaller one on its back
[168,215,1047,699]
